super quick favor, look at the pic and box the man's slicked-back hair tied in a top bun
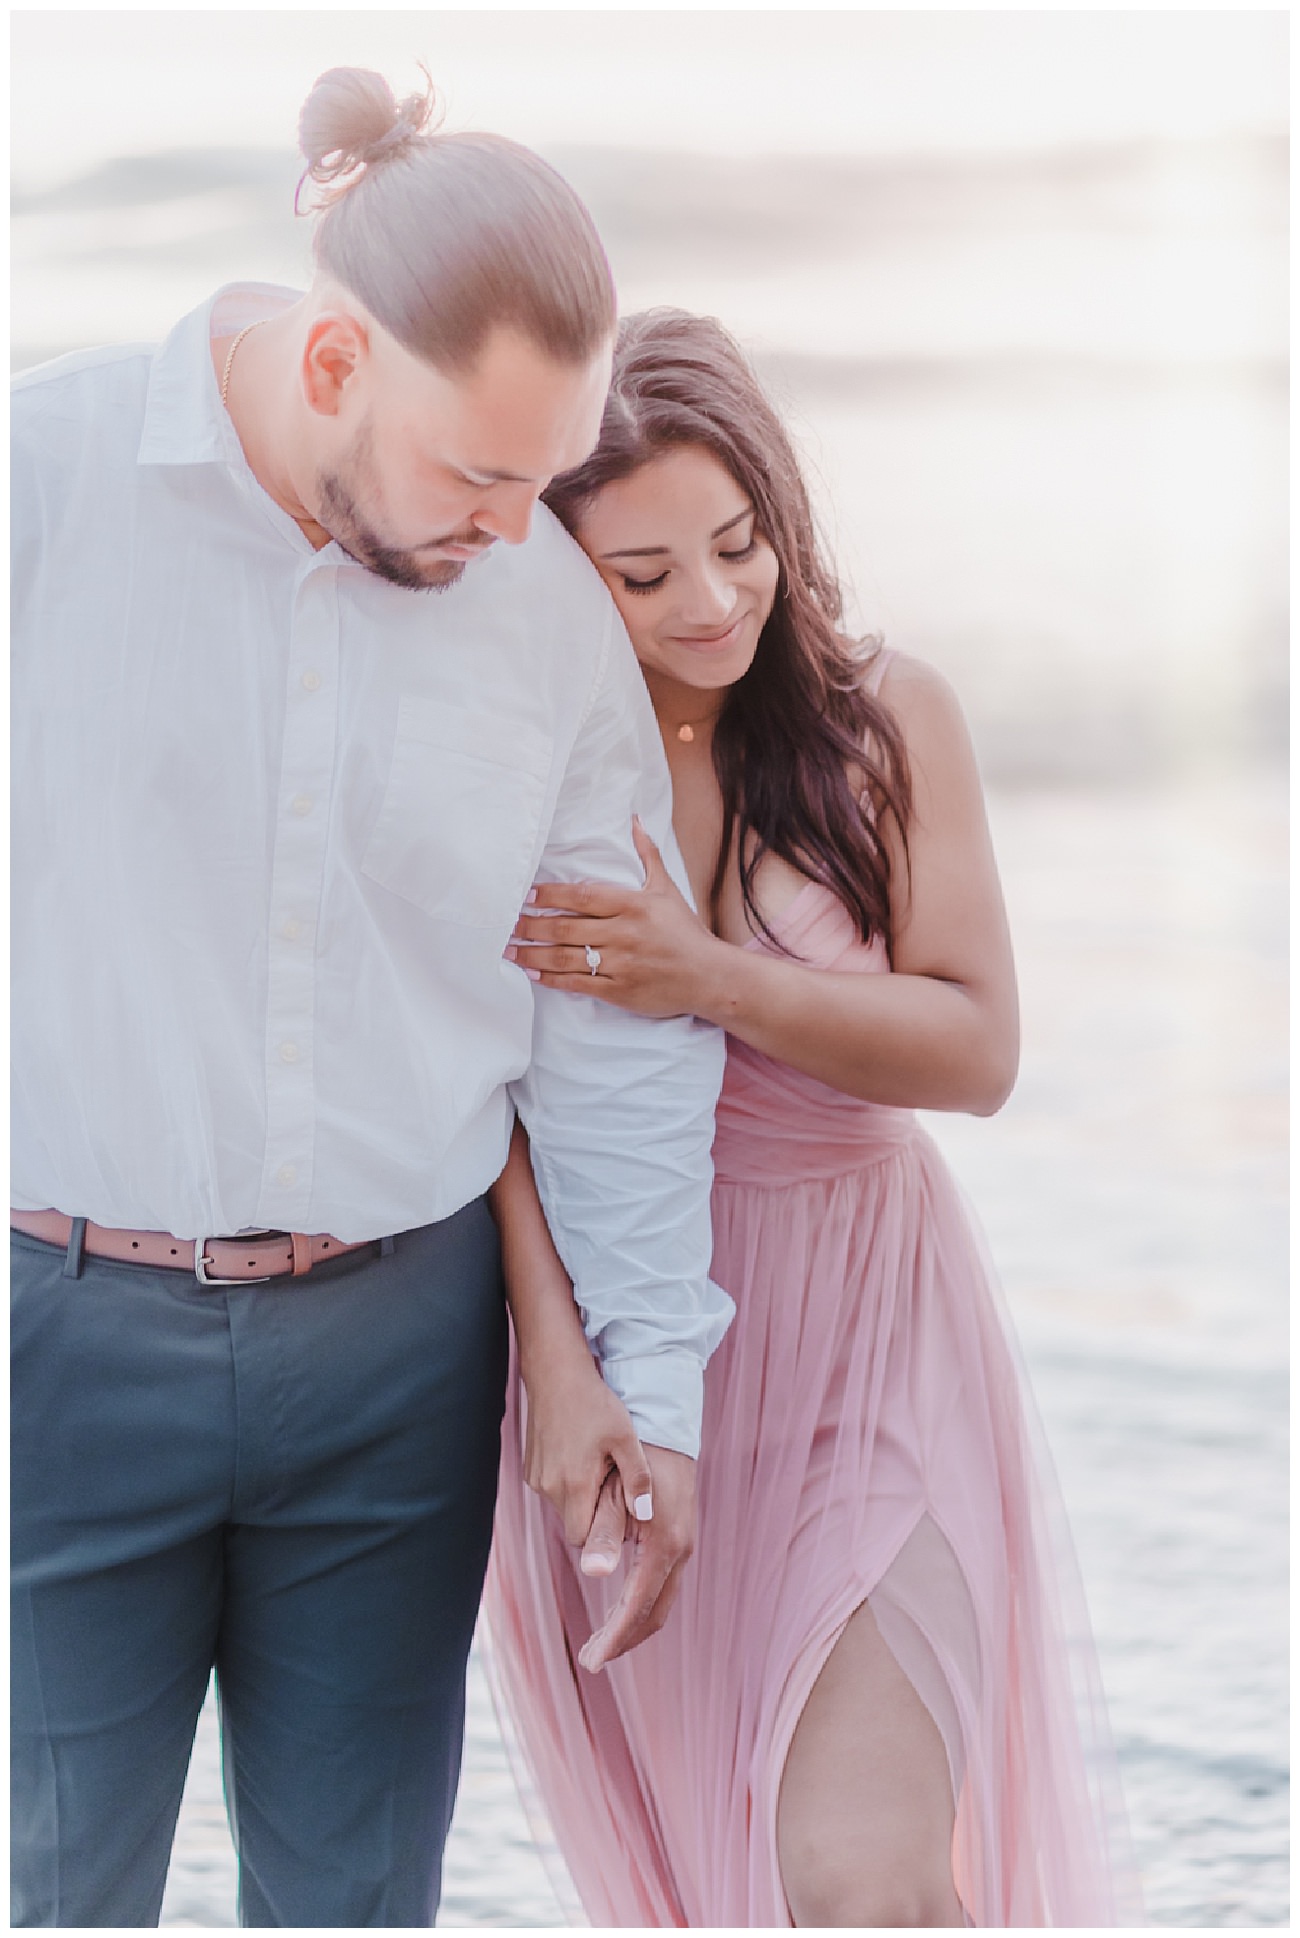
[298,68,616,370]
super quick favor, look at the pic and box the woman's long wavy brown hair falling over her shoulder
[544,310,913,946]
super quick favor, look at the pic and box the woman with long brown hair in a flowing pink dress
[488,312,1120,1926]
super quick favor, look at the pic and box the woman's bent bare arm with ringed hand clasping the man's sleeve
[517,659,1019,1114]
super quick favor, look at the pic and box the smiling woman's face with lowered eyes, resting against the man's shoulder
[577,444,779,694]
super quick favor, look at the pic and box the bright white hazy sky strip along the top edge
[10,6,1286,186]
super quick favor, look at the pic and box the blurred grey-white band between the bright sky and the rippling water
[12,136,1288,787]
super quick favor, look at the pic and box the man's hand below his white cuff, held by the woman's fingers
[577,1446,696,1674]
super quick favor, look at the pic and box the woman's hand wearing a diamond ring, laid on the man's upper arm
[506,820,727,1016]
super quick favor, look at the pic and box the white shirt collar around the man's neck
[138,283,302,465]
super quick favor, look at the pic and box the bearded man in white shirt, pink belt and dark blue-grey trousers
[12,70,728,1926]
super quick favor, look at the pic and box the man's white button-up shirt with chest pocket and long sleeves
[12,287,730,1452]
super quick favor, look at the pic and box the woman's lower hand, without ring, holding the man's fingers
[521,1341,655,1576]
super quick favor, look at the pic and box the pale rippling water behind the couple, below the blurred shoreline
[150,781,1288,1928]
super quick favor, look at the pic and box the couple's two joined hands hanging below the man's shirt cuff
[523,1347,696,1674]
